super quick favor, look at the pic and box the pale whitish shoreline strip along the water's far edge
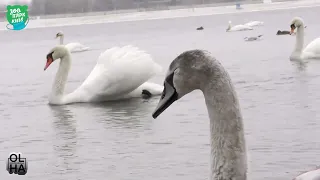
[0,0,320,30]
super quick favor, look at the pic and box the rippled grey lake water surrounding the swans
[0,5,320,180]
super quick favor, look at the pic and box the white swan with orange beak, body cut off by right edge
[290,17,320,60]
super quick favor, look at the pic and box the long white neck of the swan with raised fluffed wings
[49,53,71,104]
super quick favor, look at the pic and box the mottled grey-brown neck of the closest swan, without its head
[200,63,247,180]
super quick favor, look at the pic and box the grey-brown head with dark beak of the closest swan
[152,50,211,118]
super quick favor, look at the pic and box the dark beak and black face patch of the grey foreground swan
[152,71,178,119]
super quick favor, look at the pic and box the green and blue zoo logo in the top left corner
[6,5,29,30]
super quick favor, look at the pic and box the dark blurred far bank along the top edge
[0,0,284,19]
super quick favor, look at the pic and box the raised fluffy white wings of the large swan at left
[75,46,162,100]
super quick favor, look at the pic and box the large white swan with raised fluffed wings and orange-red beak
[44,45,163,105]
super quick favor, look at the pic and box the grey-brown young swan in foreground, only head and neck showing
[152,50,314,180]
